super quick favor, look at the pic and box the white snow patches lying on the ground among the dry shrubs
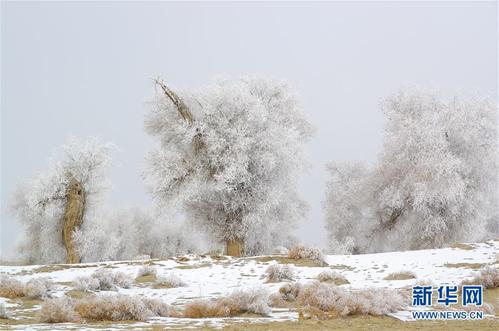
[0,240,499,330]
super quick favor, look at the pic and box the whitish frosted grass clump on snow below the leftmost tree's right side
[75,269,132,291]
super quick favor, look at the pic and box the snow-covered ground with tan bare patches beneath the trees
[0,240,499,330]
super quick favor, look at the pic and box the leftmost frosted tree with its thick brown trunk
[13,138,112,263]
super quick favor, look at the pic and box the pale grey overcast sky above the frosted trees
[0,2,498,253]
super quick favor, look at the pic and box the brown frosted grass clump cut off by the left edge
[0,275,54,299]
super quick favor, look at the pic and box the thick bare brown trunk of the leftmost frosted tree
[62,177,85,264]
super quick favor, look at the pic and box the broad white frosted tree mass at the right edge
[325,91,498,252]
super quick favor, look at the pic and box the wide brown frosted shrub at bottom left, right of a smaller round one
[74,294,152,321]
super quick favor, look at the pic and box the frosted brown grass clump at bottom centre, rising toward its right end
[183,289,270,318]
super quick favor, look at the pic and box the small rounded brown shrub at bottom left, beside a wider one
[40,296,80,323]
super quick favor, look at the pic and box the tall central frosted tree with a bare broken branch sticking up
[146,77,311,255]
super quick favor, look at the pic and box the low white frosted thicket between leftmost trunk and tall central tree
[75,207,203,262]
